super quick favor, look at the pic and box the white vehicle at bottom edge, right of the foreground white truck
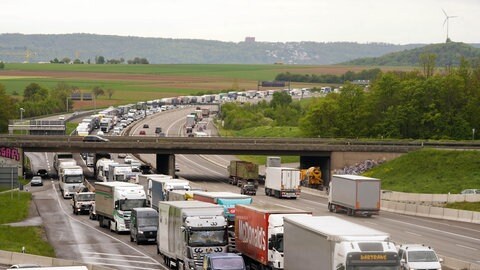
[397,244,443,270]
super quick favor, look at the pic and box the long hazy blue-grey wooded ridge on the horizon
[0,34,423,65]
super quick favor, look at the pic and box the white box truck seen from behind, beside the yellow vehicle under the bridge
[265,167,300,199]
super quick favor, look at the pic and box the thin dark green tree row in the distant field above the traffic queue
[275,68,381,84]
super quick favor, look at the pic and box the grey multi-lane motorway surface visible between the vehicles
[23,108,480,269]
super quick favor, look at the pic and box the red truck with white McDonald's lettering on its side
[235,204,311,269]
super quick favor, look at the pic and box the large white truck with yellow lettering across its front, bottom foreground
[283,216,400,270]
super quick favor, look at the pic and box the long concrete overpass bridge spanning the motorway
[0,135,480,182]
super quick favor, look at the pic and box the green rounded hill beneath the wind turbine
[345,42,480,67]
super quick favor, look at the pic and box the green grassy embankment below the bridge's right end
[365,149,480,194]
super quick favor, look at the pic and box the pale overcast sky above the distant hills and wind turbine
[0,0,480,44]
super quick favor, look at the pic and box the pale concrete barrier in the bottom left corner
[0,250,112,270]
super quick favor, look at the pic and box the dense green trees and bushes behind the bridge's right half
[222,59,480,140]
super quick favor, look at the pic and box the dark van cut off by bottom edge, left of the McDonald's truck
[202,253,246,270]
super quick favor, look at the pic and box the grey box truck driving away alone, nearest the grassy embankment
[328,174,381,217]
